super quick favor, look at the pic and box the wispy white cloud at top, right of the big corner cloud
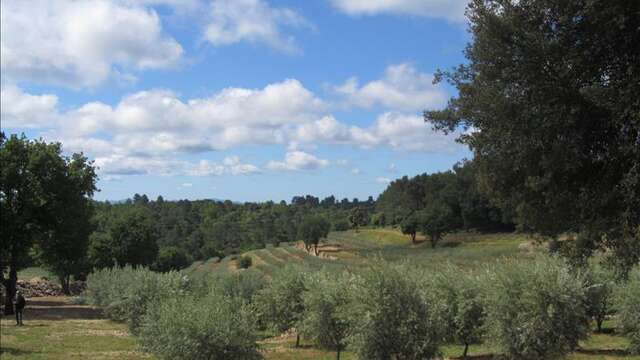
[205,0,313,52]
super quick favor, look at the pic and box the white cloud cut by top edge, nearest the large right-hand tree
[330,0,468,22]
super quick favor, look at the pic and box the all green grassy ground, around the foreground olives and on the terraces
[0,229,640,360]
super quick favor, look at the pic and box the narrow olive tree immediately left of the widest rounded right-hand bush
[425,265,484,358]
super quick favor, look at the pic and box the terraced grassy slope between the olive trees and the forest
[186,228,533,276]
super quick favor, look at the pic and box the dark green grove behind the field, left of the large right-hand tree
[373,161,515,246]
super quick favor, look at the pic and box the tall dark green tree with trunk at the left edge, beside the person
[0,133,96,314]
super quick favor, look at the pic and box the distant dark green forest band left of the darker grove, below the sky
[88,194,375,271]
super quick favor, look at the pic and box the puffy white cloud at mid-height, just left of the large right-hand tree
[334,63,449,111]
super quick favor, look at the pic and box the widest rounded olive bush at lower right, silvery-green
[485,256,589,359]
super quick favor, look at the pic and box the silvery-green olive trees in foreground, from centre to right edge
[255,257,640,359]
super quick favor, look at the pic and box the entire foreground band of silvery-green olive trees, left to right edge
[85,255,640,359]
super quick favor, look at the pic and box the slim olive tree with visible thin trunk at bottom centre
[302,273,351,360]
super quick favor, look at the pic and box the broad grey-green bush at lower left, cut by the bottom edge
[140,293,260,360]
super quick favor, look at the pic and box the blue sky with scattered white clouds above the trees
[0,0,472,202]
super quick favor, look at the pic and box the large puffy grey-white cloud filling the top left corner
[0,0,183,88]
